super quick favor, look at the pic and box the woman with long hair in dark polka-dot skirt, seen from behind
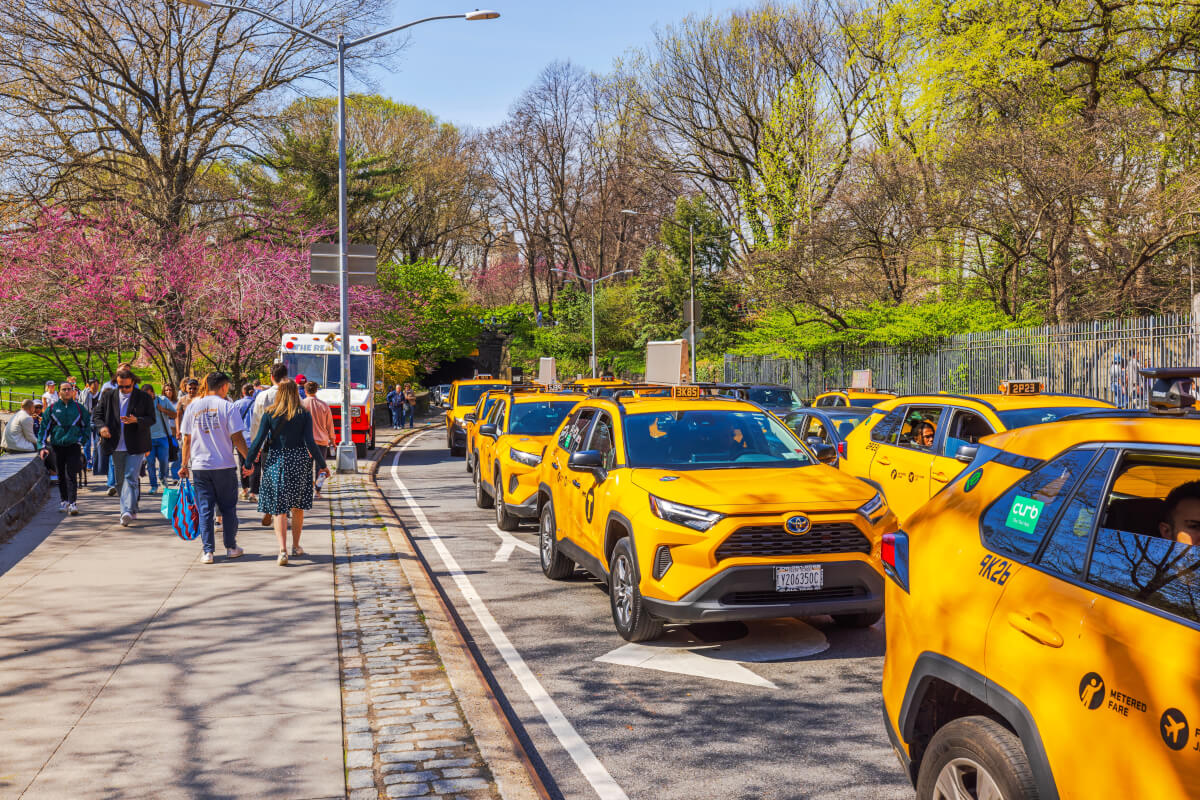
[246,379,329,566]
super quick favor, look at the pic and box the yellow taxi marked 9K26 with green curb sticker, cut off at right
[882,368,1200,800]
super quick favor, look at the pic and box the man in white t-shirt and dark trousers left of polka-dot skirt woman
[179,372,246,564]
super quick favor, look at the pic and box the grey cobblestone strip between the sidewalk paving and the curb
[325,460,500,800]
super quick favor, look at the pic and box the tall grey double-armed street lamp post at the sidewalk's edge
[179,0,500,473]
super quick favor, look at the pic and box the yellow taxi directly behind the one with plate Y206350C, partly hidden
[475,390,586,530]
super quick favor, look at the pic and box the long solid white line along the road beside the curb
[391,433,629,800]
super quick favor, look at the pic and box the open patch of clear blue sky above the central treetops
[352,0,744,127]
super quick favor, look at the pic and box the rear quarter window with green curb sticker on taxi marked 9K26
[980,450,1096,561]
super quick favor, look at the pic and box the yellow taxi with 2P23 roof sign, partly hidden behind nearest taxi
[838,380,1112,523]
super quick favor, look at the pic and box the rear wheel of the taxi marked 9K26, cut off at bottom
[917,716,1039,800]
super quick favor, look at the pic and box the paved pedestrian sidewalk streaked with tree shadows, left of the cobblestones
[0,479,346,798]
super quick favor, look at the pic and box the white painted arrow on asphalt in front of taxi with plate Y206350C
[596,619,829,688]
